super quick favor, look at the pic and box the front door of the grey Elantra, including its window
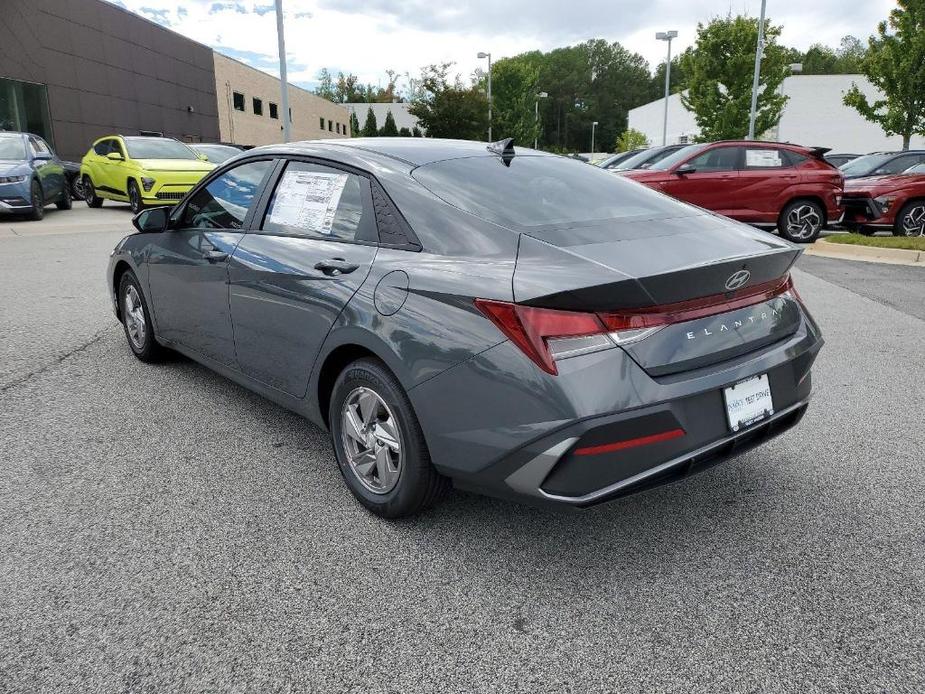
[147,158,275,367]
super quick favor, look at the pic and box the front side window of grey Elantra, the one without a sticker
[180,161,273,230]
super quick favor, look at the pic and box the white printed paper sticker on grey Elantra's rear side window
[269,171,348,234]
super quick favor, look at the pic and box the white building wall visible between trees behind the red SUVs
[629,75,925,154]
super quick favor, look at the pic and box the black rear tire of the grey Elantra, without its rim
[328,359,450,518]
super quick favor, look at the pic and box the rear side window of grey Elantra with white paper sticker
[263,161,377,241]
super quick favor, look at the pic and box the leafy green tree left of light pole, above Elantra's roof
[408,63,488,140]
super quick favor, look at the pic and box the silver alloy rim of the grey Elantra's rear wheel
[341,386,402,494]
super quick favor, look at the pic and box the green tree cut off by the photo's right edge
[844,0,925,149]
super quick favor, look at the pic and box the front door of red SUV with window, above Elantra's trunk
[662,145,742,216]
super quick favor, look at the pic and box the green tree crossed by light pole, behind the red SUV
[681,16,789,141]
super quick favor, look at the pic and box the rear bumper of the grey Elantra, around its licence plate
[409,308,823,507]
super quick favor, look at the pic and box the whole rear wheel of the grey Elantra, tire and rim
[329,359,450,518]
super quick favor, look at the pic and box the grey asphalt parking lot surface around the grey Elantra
[0,209,925,694]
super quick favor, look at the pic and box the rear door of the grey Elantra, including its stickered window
[229,160,378,397]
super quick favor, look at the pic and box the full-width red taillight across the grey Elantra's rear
[475,275,802,375]
